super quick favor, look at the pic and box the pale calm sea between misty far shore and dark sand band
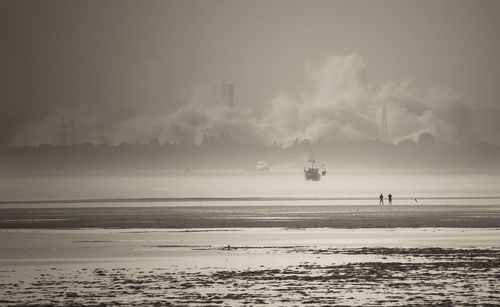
[0,169,500,202]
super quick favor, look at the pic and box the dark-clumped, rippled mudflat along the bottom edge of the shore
[0,249,500,306]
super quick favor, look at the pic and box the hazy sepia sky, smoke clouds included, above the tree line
[0,0,500,144]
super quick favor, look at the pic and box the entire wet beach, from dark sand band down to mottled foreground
[0,202,500,306]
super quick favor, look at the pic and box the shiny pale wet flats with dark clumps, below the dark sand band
[0,228,500,306]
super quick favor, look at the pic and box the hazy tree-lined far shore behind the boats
[0,133,500,172]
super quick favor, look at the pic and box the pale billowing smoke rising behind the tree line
[16,54,477,144]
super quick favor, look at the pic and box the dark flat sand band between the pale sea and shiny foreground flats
[0,203,500,229]
